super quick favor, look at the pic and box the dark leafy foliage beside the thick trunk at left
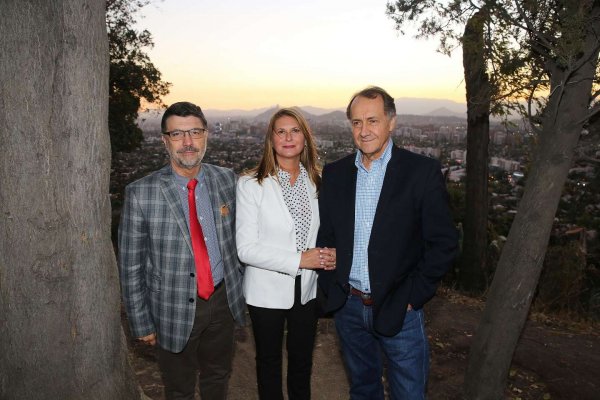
[106,0,170,152]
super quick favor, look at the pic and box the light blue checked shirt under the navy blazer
[349,139,394,293]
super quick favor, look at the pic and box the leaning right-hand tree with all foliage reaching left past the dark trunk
[392,0,600,399]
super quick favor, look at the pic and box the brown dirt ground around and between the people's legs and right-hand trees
[124,289,600,400]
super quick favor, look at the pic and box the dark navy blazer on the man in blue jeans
[317,146,458,336]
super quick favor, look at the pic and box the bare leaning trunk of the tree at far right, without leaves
[465,2,600,399]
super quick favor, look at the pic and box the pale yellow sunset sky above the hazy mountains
[138,0,465,109]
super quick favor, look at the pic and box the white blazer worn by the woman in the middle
[235,176,319,309]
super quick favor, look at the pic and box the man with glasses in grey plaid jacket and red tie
[119,102,245,399]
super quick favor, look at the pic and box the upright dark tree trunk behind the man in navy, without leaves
[458,8,491,293]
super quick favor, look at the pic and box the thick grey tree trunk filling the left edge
[0,0,140,400]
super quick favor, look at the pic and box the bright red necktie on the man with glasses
[187,179,215,300]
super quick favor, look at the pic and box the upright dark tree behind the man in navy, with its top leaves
[387,1,502,293]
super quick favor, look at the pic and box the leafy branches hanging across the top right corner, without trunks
[387,0,599,123]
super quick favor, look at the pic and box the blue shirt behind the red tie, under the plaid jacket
[173,169,223,286]
